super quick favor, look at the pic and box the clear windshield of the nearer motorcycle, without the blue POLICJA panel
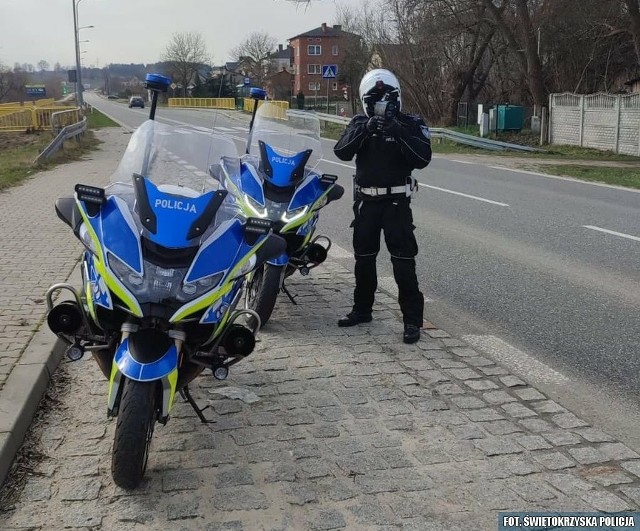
[111,120,239,197]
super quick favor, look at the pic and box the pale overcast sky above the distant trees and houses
[0,0,344,68]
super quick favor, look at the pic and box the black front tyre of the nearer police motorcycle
[111,379,158,490]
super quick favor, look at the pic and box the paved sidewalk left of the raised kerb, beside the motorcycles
[0,128,129,391]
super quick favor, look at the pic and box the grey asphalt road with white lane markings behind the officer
[87,91,640,442]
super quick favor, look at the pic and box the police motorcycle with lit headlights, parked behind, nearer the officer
[214,88,344,325]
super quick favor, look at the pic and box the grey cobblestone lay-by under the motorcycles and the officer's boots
[0,261,640,531]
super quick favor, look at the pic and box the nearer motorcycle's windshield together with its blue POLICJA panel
[106,120,241,248]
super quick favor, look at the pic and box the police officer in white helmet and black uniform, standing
[334,69,431,343]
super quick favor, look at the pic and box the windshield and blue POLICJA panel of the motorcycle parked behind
[249,101,322,187]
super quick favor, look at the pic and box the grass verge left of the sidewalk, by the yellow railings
[0,110,118,190]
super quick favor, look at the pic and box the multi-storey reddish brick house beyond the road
[289,23,355,99]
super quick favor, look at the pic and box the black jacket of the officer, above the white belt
[333,113,431,187]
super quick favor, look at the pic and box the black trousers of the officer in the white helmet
[351,197,424,327]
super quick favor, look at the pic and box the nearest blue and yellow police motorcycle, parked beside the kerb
[47,75,286,489]
